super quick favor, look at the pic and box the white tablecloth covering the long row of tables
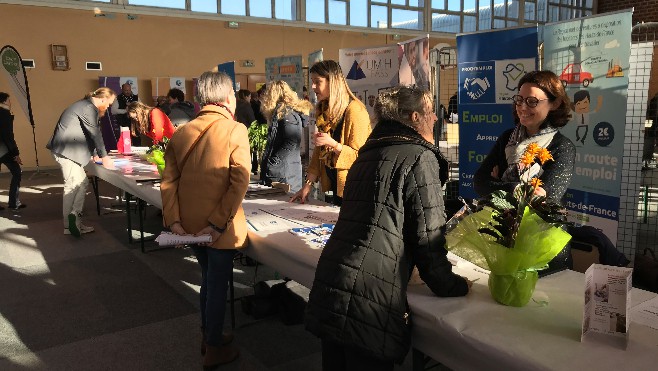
[87,159,658,370]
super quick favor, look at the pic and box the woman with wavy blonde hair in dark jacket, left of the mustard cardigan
[260,80,313,192]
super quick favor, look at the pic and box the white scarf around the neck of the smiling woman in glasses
[500,124,557,182]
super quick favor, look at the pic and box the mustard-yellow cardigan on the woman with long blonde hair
[307,100,372,197]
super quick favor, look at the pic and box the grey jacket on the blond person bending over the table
[46,99,107,166]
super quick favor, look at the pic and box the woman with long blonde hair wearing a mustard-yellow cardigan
[290,60,372,206]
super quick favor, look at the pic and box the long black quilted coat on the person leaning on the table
[305,122,468,362]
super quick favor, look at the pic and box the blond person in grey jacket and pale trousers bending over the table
[46,88,116,237]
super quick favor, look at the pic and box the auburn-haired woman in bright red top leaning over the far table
[126,102,176,144]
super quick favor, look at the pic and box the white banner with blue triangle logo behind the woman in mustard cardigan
[338,45,399,117]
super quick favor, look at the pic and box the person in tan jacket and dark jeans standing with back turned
[161,72,251,369]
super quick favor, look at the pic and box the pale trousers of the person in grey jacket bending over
[53,153,89,228]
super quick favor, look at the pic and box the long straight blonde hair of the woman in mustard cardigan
[308,60,365,124]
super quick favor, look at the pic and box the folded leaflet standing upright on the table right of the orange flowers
[581,264,633,341]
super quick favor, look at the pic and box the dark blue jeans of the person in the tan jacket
[192,246,236,346]
